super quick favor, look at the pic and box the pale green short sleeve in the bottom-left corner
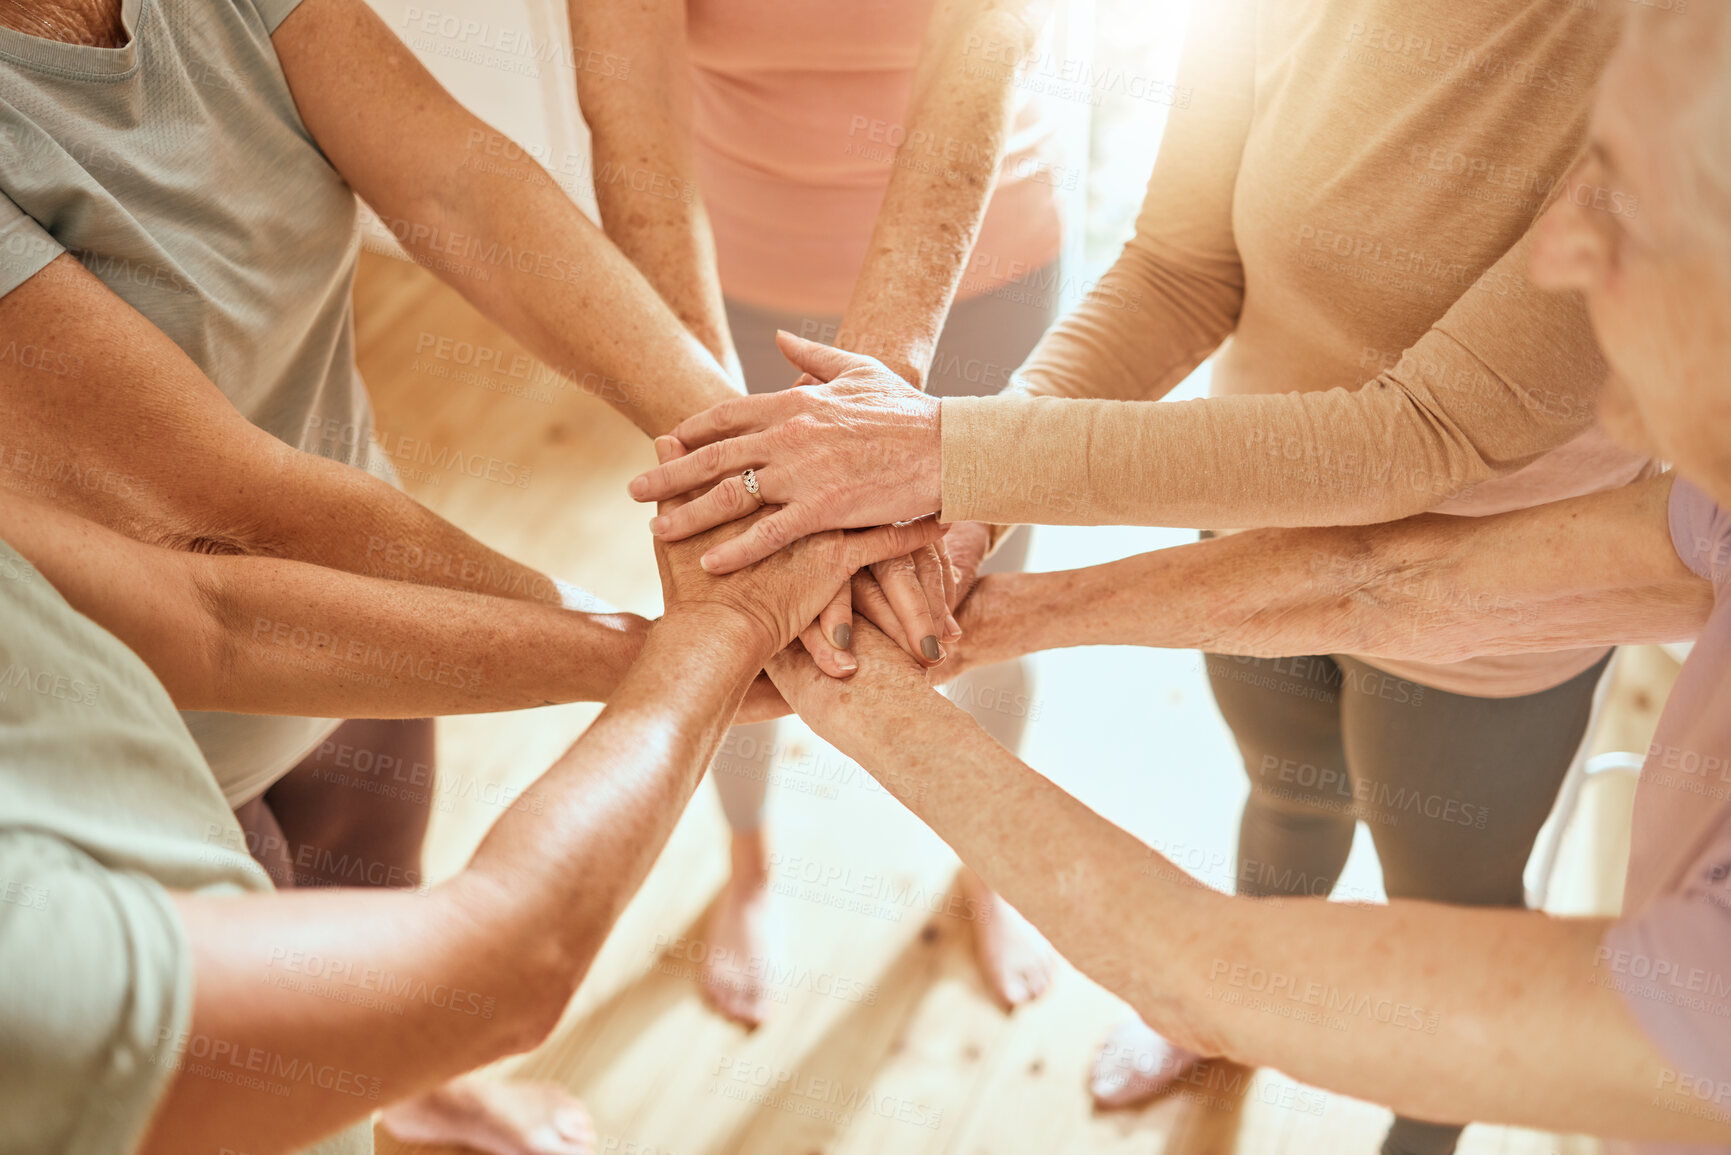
[0,828,192,1155]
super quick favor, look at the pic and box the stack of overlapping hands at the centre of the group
[630,332,992,699]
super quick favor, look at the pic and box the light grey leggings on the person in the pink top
[710,267,1058,833]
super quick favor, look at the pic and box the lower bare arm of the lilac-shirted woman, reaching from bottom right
[770,627,1731,1143]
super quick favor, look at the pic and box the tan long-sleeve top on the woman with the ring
[942,0,1651,696]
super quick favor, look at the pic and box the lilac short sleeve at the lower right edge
[1599,841,1731,1084]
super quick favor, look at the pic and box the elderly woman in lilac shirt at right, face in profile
[770,5,1731,1155]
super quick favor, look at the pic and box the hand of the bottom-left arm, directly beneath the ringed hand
[656,439,942,655]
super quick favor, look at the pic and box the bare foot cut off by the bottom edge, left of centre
[381,1075,597,1155]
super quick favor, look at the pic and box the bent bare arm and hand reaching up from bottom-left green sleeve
[144,498,936,1155]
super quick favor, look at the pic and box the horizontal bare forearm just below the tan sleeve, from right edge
[956,474,1714,670]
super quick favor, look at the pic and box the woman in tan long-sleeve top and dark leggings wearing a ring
[639,0,1653,1155]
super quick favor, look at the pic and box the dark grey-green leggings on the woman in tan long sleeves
[1208,655,1610,1155]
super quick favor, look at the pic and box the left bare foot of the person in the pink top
[699,831,781,1027]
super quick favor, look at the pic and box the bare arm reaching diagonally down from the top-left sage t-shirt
[272,0,737,435]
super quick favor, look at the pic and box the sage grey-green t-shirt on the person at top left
[0,0,372,805]
